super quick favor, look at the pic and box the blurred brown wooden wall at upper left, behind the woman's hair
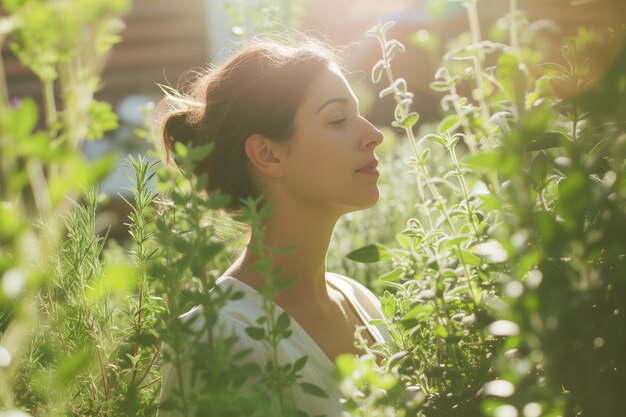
[2,0,209,109]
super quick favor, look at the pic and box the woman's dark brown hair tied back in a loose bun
[161,38,335,214]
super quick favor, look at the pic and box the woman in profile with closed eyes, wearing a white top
[157,35,388,416]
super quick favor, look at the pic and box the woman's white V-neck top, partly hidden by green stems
[158,273,391,417]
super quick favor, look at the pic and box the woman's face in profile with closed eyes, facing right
[282,67,383,214]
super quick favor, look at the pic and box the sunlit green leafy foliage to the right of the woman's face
[340,0,626,416]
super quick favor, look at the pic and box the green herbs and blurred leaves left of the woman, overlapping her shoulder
[0,0,325,416]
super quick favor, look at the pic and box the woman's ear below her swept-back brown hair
[244,133,286,178]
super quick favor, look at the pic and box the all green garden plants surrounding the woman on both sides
[0,0,626,417]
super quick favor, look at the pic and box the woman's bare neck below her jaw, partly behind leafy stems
[225,202,340,306]
